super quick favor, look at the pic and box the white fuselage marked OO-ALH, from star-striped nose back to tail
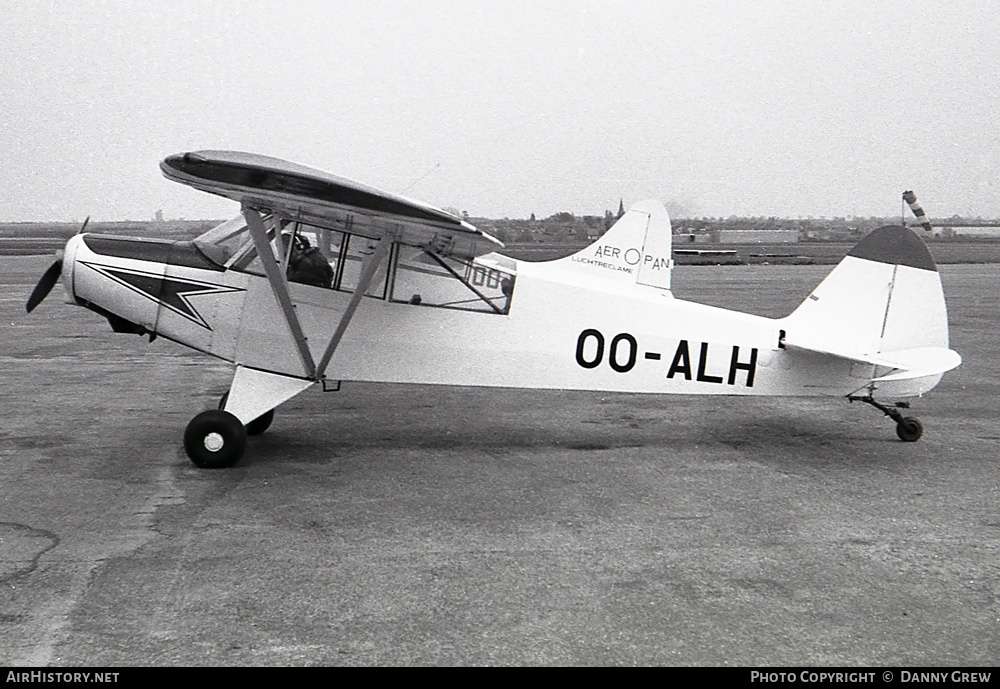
[64,234,872,396]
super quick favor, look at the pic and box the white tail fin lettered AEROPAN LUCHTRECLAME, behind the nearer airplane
[553,201,673,290]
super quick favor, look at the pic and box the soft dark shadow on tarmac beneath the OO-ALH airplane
[215,384,916,466]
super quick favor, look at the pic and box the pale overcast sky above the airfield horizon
[0,0,1000,220]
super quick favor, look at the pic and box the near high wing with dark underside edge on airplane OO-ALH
[160,151,503,259]
